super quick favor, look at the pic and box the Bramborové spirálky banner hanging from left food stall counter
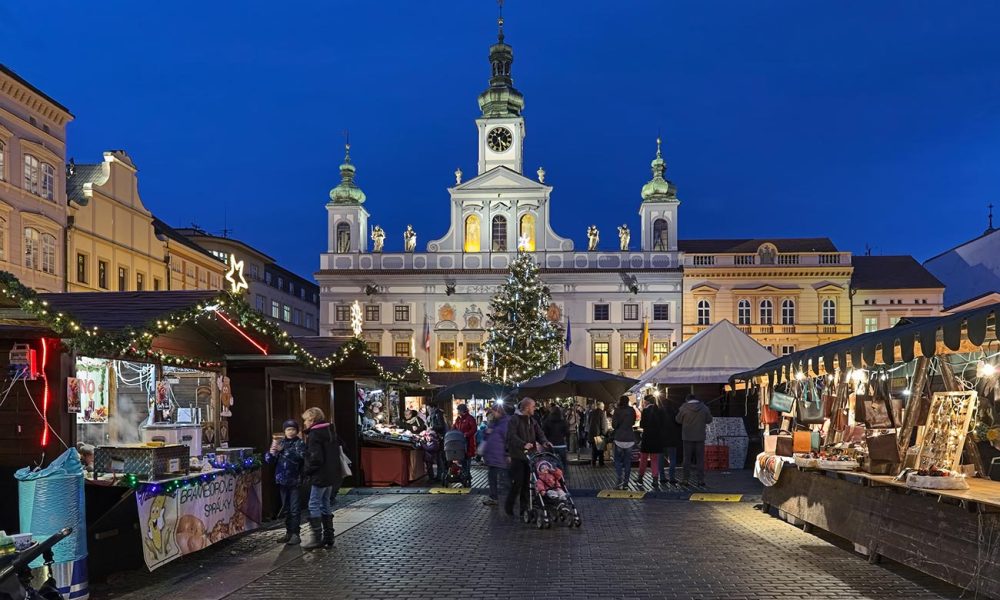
[135,469,262,571]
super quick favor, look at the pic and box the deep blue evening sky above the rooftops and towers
[0,0,1000,274]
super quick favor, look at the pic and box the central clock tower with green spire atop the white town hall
[476,9,524,175]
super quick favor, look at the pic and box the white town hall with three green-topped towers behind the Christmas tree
[316,21,683,375]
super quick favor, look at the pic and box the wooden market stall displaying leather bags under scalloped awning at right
[733,305,1000,598]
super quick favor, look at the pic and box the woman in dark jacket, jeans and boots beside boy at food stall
[302,407,344,550]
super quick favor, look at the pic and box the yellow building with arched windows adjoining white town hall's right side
[678,238,852,356]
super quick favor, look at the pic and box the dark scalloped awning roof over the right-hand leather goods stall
[731,304,1000,381]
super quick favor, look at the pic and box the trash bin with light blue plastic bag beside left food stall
[14,448,90,600]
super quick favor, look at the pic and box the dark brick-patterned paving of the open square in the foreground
[226,495,960,600]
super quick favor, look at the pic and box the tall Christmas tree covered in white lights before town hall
[483,252,565,383]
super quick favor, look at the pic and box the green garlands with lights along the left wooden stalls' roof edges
[0,271,429,384]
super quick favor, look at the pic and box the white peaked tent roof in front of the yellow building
[632,320,774,390]
